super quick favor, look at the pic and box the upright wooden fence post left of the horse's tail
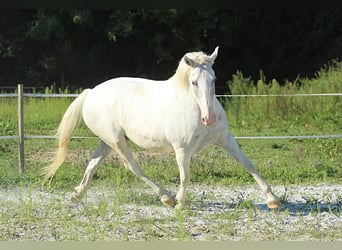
[18,84,25,174]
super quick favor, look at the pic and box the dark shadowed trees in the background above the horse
[0,9,342,93]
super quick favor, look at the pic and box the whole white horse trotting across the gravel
[44,47,280,208]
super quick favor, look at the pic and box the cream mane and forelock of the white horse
[170,52,214,88]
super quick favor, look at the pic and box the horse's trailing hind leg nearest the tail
[71,141,112,202]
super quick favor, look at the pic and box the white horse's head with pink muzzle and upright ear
[182,47,218,126]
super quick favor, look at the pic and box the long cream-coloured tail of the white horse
[42,89,90,183]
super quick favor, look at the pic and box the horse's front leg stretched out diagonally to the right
[219,134,280,208]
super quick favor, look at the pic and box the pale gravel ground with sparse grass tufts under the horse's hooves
[0,184,342,241]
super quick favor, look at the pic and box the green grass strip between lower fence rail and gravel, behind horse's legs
[0,136,342,190]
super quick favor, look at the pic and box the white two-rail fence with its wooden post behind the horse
[0,84,342,173]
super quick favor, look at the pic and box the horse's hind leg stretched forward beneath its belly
[111,135,176,207]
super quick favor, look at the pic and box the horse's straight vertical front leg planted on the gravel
[175,148,191,209]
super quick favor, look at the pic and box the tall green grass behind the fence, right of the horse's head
[221,61,342,134]
